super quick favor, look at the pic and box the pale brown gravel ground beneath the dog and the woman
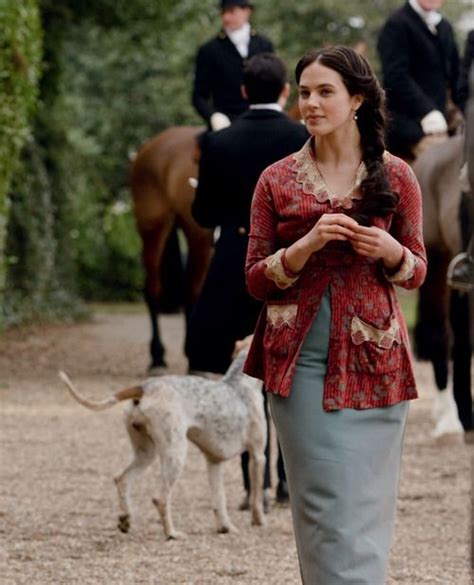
[0,310,472,585]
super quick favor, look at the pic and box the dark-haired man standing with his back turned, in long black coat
[186,53,308,512]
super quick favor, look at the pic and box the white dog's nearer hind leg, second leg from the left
[153,429,188,540]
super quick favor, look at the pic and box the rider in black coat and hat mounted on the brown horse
[192,0,273,130]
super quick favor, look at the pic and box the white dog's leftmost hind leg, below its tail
[114,421,156,532]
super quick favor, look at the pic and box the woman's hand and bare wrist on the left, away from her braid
[285,213,358,273]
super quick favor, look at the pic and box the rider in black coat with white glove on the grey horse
[378,0,459,159]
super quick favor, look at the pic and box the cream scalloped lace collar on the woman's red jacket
[291,138,366,209]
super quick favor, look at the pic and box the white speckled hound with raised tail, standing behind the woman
[59,342,266,539]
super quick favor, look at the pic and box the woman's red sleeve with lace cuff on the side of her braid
[385,163,426,289]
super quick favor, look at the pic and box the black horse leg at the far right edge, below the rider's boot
[449,290,472,430]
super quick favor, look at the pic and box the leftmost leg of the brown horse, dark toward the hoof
[140,218,174,368]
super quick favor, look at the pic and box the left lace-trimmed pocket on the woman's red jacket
[263,303,298,356]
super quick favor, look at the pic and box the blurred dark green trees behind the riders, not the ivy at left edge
[0,0,472,322]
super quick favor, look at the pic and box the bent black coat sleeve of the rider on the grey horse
[377,20,438,119]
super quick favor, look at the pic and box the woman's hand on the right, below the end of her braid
[350,225,403,269]
